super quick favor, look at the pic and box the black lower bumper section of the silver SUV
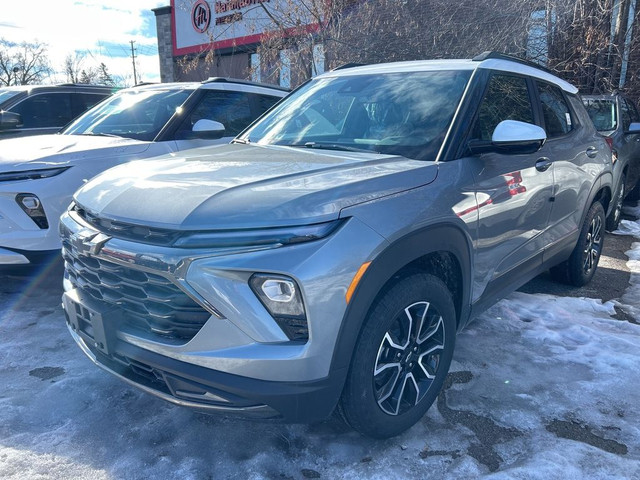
[63,292,346,423]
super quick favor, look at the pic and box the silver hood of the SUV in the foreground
[75,144,437,230]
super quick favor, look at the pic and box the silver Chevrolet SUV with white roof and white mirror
[61,54,612,437]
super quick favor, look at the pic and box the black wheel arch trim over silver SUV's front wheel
[332,224,471,370]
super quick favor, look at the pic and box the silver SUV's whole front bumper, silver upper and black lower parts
[61,206,383,422]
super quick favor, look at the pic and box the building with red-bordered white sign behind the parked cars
[154,0,325,87]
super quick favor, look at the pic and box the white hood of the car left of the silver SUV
[0,135,150,172]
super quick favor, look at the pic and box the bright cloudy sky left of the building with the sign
[0,0,169,84]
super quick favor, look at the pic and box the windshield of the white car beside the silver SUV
[62,89,193,141]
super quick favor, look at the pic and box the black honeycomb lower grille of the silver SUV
[62,239,211,341]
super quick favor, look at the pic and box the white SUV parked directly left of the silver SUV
[0,78,287,266]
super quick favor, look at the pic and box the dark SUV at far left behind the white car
[0,84,117,140]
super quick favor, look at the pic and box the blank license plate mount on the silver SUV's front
[62,291,114,355]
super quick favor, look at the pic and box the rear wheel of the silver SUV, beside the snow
[551,202,605,287]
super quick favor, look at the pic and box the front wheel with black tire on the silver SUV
[339,273,456,438]
